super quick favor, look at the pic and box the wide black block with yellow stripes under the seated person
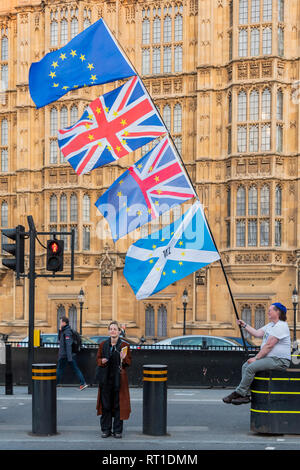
[250,369,300,434]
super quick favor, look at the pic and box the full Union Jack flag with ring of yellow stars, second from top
[58,77,168,174]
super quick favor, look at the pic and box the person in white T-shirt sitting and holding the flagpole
[223,302,291,405]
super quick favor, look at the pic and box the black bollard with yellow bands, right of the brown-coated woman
[143,364,168,436]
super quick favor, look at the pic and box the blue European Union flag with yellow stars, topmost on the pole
[29,19,136,108]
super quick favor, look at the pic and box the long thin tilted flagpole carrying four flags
[102,19,248,353]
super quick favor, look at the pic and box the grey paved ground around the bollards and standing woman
[0,386,300,451]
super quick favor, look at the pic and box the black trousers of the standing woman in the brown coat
[100,384,123,434]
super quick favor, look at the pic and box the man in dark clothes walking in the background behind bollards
[56,317,88,390]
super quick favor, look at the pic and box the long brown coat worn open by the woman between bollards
[96,340,131,420]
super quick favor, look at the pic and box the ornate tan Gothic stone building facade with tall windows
[0,0,300,339]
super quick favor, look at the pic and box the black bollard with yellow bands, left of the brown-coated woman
[32,364,57,436]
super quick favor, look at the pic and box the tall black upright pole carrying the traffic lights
[27,215,36,394]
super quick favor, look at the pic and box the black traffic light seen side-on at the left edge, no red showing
[2,225,25,279]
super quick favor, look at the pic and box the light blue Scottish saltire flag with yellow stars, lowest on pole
[124,201,220,300]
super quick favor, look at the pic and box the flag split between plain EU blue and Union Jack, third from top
[95,136,195,241]
